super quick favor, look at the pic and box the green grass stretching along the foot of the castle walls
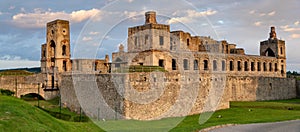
[0,95,300,132]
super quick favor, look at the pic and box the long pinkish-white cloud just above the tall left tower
[12,8,101,28]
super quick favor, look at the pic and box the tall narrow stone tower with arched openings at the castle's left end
[41,20,71,88]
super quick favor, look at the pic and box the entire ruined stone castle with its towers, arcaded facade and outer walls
[1,11,299,120]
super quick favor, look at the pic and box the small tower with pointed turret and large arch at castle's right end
[260,27,286,77]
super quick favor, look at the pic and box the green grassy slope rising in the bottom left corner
[0,95,100,131]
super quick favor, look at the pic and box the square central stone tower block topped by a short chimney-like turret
[127,11,170,52]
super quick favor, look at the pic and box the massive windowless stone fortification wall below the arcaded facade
[61,72,296,120]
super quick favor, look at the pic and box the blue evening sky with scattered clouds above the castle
[0,0,300,71]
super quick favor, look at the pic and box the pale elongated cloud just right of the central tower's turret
[167,9,217,24]
